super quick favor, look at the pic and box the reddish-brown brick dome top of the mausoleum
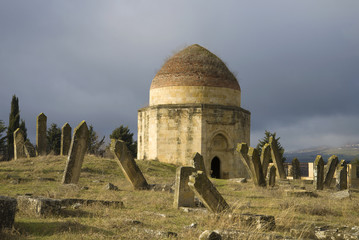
[151,44,240,91]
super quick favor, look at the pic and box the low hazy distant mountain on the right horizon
[284,143,359,162]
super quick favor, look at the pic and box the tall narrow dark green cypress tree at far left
[7,94,20,160]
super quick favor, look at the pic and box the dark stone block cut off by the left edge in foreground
[0,196,17,231]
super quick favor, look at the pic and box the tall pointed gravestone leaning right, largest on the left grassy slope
[62,121,89,184]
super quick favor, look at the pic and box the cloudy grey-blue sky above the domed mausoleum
[0,0,359,151]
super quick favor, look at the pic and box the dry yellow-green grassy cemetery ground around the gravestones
[0,155,359,239]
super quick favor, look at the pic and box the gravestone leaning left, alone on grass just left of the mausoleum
[111,139,149,189]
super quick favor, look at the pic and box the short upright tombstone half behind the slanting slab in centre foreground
[173,167,196,208]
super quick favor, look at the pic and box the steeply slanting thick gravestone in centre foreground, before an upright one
[188,171,229,213]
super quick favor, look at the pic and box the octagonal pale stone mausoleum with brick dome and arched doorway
[137,44,250,178]
